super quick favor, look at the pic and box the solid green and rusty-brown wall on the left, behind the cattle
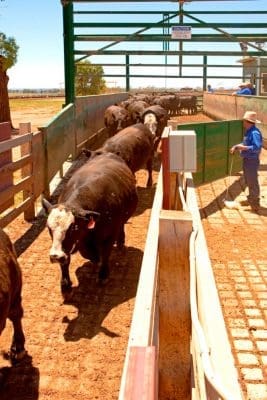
[39,93,128,197]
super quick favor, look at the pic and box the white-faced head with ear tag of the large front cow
[42,199,100,263]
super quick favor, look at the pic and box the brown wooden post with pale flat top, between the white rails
[159,210,193,400]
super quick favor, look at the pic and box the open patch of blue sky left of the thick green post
[0,0,64,89]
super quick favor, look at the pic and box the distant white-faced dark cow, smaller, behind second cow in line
[142,105,168,150]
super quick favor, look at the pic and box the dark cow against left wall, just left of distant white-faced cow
[104,105,130,137]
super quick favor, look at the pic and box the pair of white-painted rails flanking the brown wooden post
[119,140,245,400]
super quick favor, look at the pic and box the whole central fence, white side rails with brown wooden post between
[119,126,242,400]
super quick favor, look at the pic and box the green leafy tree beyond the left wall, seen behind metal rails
[75,60,106,96]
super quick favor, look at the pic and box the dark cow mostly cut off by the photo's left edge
[0,228,26,363]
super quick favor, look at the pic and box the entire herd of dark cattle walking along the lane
[0,90,196,363]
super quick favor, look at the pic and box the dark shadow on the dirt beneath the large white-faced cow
[63,247,143,341]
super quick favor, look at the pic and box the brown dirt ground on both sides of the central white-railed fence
[0,107,267,400]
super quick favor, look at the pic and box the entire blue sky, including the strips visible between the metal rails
[0,0,267,89]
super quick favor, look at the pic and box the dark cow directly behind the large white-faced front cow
[83,124,154,186]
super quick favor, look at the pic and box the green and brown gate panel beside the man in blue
[177,120,243,185]
